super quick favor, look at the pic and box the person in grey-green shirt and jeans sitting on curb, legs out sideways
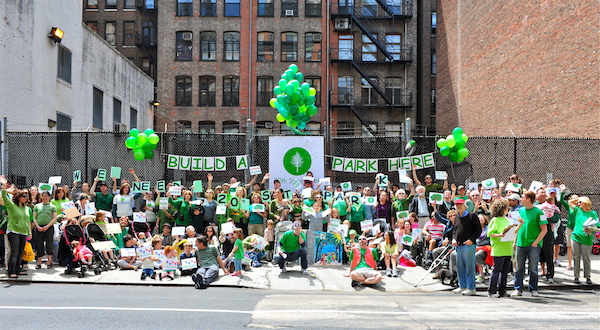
[192,235,229,289]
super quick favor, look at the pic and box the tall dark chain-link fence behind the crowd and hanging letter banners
[7,132,600,209]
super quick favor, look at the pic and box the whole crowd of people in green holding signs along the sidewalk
[0,168,600,297]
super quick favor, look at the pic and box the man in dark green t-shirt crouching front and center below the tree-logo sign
[273,221,308,274]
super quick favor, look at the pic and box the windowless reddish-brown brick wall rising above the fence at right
[436,0,600,138]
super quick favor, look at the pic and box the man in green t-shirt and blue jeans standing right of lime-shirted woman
[510,191,548,297]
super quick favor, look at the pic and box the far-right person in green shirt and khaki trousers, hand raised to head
[569,196,600,284]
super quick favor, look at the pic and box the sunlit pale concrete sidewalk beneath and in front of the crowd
[0,255,600,292]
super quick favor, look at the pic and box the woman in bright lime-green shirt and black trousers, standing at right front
[487,199,514,298]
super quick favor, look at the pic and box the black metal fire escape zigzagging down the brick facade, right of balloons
[331,0,413,135]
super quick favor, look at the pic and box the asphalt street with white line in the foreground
[0,283,600,329]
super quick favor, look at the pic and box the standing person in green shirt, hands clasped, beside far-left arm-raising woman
[33,191,57,269]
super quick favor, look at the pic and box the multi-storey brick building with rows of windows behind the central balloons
[155,0,435,136]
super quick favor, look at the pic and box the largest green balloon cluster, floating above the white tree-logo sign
[269,64,318,134]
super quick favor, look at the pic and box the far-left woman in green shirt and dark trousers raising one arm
[0,177,33,278]
